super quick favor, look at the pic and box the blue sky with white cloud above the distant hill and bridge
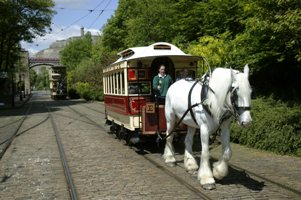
[21,0,118,56]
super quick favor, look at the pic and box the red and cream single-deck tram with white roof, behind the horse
[103,42,201,142]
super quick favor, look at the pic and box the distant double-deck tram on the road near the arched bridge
[49,66,67,99]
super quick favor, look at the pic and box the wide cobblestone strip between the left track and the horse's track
[52,105,204,199]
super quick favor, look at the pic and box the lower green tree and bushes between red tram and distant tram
[61,33,108,100]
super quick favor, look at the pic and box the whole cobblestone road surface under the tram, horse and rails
[0,91,301,200]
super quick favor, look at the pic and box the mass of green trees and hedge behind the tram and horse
[58,0,301,155]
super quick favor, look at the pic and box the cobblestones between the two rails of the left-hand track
[0,103,69,200]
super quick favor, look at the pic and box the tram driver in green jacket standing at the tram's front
[153,65,173,103]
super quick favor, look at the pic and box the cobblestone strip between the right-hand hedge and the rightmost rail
[212,141,301,194]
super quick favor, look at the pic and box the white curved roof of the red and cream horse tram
[113,42,200,64]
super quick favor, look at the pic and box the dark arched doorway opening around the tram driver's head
[151,57,175,82]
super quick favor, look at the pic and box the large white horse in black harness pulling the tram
[163,65,252,189]
